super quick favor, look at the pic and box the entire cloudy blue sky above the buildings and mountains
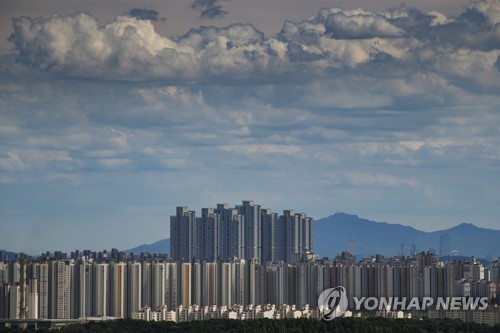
[0,0,500,254]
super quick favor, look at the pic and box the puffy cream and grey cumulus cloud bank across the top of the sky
[5,0,500,91]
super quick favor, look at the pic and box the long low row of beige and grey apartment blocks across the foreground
[0,253,500,320]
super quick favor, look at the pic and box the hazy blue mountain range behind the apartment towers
[126,213,500,259]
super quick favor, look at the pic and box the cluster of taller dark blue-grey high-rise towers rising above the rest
[170,201,313,264]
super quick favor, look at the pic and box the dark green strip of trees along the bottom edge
[0,317,500,333]
